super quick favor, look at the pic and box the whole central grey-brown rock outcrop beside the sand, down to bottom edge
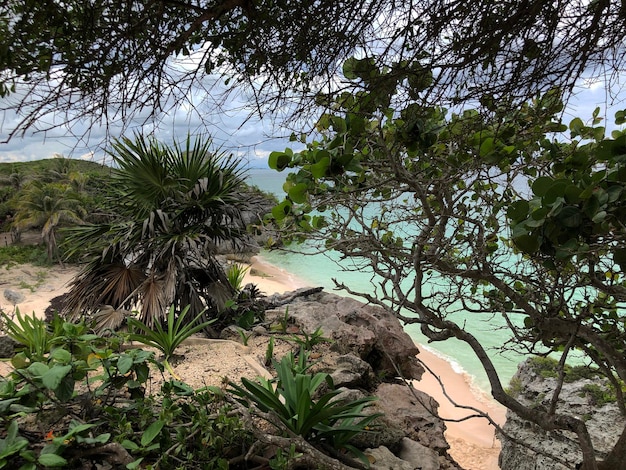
[258,289,461,470]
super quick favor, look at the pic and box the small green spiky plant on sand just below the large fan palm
[128,305,215,377]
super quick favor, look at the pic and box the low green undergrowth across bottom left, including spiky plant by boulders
[0,312,378,470]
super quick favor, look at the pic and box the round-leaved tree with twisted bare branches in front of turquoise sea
[269,58,626,470]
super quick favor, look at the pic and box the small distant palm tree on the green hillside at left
[12,181,84,264]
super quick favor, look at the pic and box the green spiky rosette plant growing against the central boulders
[230,349,381,462]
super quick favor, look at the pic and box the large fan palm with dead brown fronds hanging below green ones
[65,136,246,332]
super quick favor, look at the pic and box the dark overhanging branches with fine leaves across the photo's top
[0,0,626,138]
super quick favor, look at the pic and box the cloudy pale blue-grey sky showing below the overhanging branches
[0,76,626,168]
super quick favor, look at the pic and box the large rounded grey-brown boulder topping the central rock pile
[266,292,424,380]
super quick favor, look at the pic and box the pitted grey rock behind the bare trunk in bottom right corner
[499,361,626,470]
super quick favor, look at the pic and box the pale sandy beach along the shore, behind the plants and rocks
[0,257,505,470]
